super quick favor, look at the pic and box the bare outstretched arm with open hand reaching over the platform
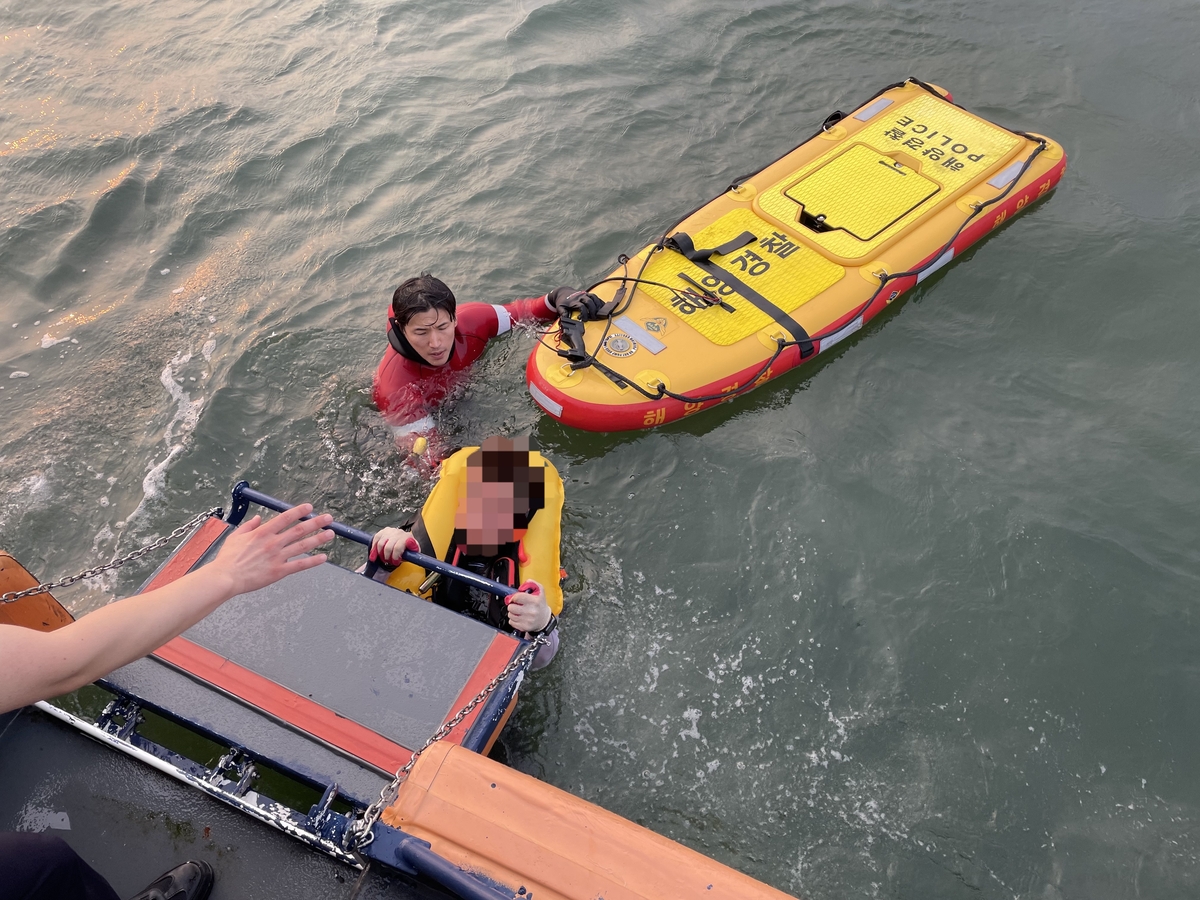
[0,503,334,712]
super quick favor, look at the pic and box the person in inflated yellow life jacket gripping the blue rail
[370,436,563,668]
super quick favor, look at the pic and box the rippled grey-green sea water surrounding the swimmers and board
[0,0,1200,900]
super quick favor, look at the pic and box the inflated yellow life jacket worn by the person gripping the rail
[388,446,563,616]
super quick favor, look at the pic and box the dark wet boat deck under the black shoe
[0,708,446,900]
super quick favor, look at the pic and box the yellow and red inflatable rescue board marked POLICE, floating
[526,80,1067,431]
